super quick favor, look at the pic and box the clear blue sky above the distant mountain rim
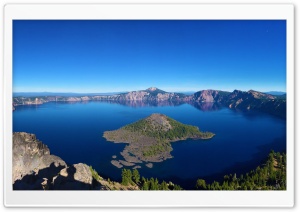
[13,20,286,93]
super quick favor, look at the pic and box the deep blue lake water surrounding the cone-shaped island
[13,102,286,188]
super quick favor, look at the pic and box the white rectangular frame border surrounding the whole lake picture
[4,4,294,207]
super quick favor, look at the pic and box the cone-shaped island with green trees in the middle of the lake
[103,113,215,168]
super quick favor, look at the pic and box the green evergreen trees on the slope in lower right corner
[195,150,286,190]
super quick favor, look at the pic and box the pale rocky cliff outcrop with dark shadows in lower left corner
[12,132,113,190]
